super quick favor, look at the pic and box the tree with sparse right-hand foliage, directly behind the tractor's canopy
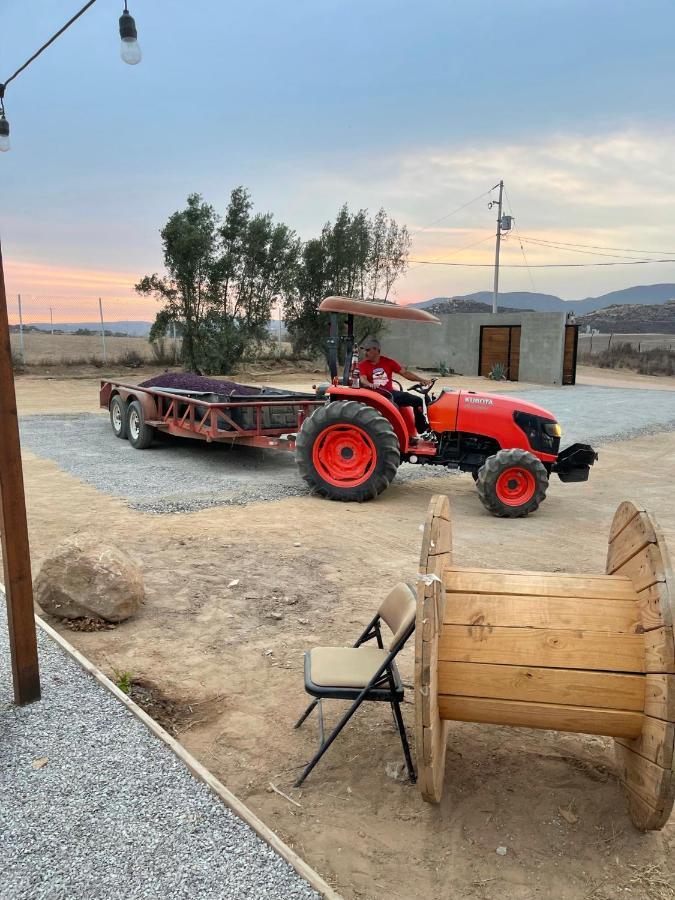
[285,204,410,354]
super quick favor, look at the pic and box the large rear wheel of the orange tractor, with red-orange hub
[295,400,401,503]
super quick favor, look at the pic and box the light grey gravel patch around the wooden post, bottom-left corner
[0,592,318,900]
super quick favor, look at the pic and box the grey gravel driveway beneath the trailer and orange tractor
[21,385,675,513]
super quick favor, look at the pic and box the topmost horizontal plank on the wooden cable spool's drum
[443,566,647,600]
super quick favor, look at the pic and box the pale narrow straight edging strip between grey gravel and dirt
[32,612,343,900]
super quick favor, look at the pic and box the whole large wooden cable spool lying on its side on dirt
[415,495,675,831]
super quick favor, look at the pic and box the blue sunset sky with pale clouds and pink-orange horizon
[0,0,675,321]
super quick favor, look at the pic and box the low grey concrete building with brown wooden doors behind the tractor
[381,312,578,384]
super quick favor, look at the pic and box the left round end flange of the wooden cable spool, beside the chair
[415,495,452,803]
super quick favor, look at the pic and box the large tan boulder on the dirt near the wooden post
[33,534,145,622]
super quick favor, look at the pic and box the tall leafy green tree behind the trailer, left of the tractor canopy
[136,187,300,374]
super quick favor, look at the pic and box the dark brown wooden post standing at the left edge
[0,234,40,706]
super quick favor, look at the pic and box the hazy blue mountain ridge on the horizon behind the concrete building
[411,284,675,316]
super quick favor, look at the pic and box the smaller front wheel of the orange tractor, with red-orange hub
[476,449,548,519]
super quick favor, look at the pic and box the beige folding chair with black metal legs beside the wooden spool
[295,582,417,787]
